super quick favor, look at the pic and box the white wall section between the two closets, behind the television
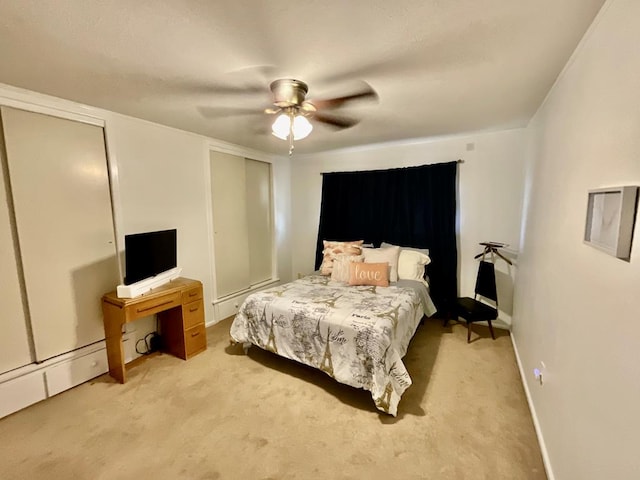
[106,118,213,341]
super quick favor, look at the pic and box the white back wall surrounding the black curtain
[291,129,524,326]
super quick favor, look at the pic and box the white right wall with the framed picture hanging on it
[513,0,640,480]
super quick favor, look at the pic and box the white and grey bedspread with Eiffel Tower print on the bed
[230,275,435,416]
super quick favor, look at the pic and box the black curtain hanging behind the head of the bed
[315,162,458,312]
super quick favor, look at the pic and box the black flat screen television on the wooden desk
[124,228,178,285]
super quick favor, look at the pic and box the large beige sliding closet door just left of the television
[2,107,118,361]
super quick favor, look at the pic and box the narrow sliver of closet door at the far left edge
[0,145,32,373]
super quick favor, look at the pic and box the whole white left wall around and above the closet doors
[0,84,291,338]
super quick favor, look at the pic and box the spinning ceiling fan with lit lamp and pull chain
[200,78,378,155]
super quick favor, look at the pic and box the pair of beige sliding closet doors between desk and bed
[210,151,273,298]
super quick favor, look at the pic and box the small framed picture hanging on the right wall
[584,186,638,261]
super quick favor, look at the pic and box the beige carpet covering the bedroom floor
[0,320,546,480]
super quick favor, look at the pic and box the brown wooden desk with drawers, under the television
[102,278,207,383]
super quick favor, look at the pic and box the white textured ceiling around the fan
[0,0,604,154]
